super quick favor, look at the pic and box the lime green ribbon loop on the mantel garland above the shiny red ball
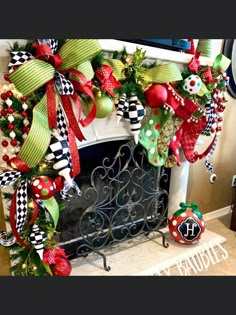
[141,63,183,83]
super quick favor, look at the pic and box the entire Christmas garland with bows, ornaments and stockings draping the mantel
[0,39,229,276]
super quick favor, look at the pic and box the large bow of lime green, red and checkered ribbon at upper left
[9,39,101,176]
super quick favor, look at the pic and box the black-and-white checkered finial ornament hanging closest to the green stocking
[124,95,146,144]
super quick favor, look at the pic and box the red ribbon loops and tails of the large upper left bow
[33,42,96,176]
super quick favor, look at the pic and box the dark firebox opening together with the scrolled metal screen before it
[54,140,170,271]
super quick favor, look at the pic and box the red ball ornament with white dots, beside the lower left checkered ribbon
[31,176,56,199]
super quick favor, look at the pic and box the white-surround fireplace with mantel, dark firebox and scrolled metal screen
[53,40,199,271]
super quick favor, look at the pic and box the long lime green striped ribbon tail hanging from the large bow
[18,94,51,168]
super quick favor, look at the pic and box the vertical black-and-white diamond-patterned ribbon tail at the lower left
[16,180,27,233]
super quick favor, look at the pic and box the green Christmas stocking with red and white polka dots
[139,107,173,166]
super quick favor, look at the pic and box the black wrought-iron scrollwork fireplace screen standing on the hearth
[56,141,169,270]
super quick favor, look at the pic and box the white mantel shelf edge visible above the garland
[98,39,213,66]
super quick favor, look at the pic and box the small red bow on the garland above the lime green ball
[95,65,122,96]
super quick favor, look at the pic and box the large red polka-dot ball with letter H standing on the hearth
[168,204,205,244]
